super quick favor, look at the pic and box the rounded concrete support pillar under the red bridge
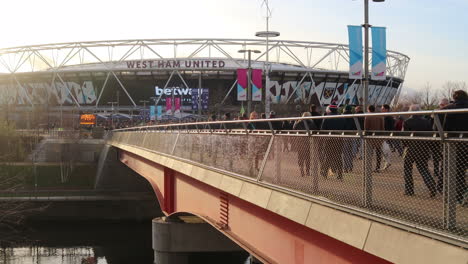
[153,216,243,264]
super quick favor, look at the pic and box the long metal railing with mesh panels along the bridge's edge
[109,109,468,247]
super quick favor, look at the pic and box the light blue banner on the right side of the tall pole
[371,27,387,80]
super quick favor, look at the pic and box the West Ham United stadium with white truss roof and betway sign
[0,38,409,126]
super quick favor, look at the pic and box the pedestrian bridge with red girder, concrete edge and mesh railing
[103,111,468,264]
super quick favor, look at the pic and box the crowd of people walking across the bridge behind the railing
[210,90,468,202]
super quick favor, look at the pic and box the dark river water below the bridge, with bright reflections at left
[0,223,248,264]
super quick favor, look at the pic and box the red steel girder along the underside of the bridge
[120,151,390,264]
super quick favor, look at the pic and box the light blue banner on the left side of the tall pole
[348,26,363,79]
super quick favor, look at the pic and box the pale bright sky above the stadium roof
[0,0,468,92]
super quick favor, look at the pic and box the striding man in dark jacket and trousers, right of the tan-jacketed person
[403,105,436,197]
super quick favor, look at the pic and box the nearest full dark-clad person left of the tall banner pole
[320,105,346,180]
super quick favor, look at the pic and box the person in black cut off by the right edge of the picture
[444,90,468,203]
